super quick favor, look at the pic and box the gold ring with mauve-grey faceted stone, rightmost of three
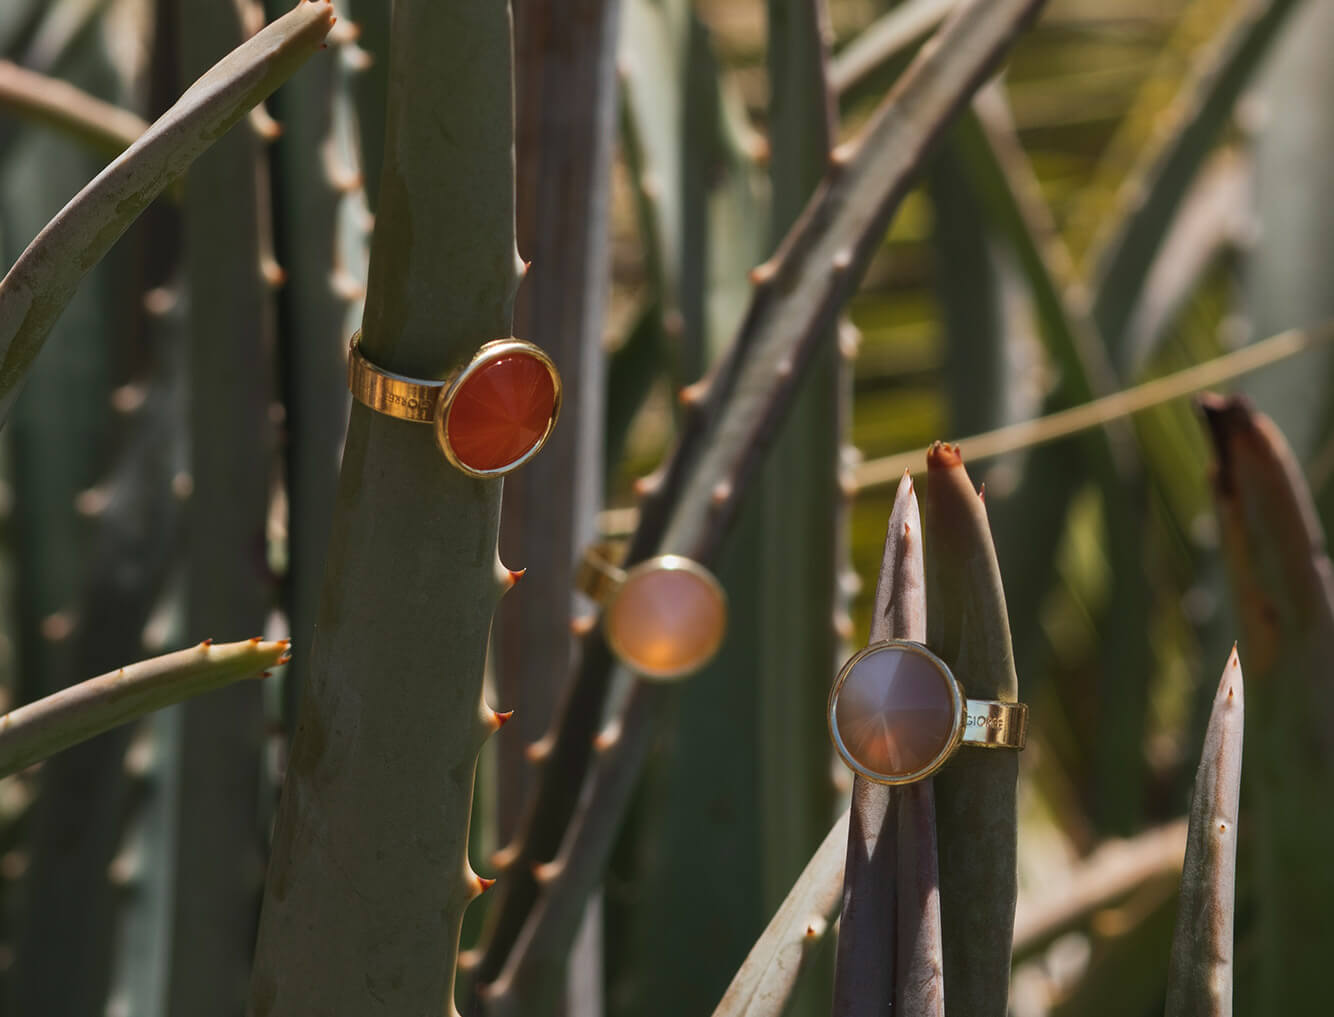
[828,639,1029,785]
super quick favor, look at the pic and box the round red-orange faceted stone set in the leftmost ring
[447,354,556,471]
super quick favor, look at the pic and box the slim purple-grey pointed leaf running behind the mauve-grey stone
[831,474,934,1017]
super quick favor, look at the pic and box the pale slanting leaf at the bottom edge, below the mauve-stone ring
[714,813,848,1017]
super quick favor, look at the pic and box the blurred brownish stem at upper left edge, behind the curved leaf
[0,60,148,156]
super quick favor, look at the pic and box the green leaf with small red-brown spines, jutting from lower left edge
[0,639,287,777]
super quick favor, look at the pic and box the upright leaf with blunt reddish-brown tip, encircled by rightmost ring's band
[926,444,1019,1017]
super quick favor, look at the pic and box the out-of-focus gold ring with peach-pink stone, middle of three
[575,543,727,679]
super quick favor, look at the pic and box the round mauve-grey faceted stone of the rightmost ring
[834,646,955,779]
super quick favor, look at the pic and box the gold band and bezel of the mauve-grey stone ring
[826,639,1029,786]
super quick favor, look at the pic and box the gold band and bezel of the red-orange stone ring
[347,330,562,476]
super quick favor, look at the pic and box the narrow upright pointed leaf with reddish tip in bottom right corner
[1166,647,1246,1017]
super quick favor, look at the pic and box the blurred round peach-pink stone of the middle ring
[603,557,727,678]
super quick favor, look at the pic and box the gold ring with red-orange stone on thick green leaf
[347,332,560,476]
